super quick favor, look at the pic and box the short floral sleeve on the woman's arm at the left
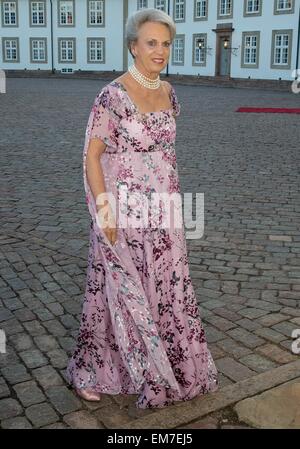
[90,85,121,148]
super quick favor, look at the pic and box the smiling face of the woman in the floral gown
[131,22,171,76]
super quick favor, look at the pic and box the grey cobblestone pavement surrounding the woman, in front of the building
[0,78,300,428]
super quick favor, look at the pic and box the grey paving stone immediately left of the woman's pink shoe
[45,387,82,415]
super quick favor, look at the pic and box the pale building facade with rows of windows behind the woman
[0,0,300,80]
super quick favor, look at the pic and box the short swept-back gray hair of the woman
[125,8,176,58]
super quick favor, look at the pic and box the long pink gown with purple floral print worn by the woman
[67,81,218,408]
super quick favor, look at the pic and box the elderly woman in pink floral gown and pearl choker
[67,9,218,408]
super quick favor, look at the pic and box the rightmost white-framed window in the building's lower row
[271,30,293,69]
